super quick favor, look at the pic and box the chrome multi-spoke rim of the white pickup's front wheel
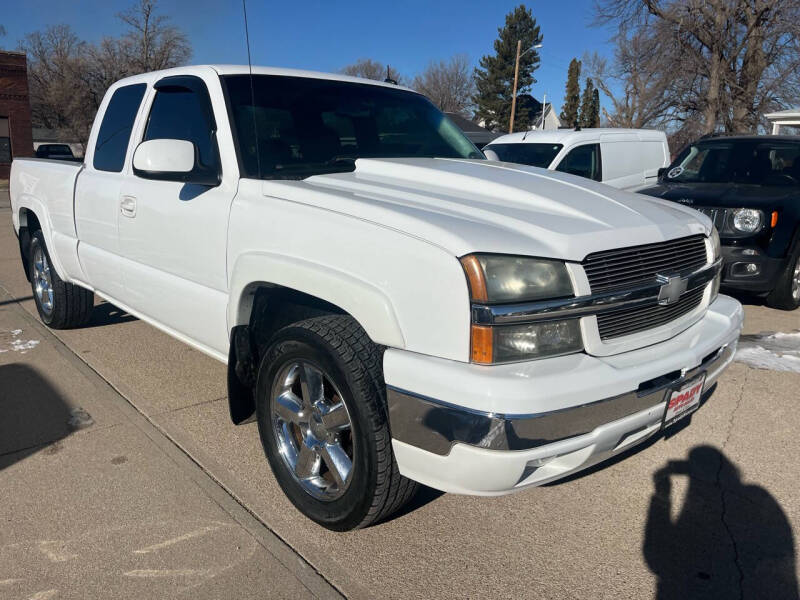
[270,360,355,501]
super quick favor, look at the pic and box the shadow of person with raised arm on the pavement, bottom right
[642,446,798,600]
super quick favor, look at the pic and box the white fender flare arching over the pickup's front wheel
[228,252,406,348]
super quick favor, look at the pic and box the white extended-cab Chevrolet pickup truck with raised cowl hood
[10,66,742,530]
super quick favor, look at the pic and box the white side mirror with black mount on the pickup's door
[133,140,220,186]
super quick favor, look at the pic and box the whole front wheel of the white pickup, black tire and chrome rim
[256,315,417,531]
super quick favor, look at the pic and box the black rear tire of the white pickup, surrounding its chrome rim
[28,230,94,329]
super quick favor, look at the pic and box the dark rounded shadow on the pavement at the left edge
[0,363,87,471]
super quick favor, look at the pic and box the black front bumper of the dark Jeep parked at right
[722,246,787,294]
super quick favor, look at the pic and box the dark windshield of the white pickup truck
[223,75,483,179]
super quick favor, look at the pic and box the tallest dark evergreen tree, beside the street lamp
[474,5,542,131]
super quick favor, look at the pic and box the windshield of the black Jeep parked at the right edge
[665,138,800,186]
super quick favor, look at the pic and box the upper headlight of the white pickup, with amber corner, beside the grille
[461,254,573,304]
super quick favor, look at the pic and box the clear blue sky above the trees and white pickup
[0,0,611,117]
